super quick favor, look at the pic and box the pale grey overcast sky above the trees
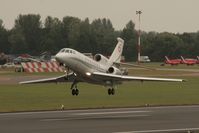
[0,0,199,33]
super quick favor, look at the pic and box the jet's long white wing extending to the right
[92,72,185,82]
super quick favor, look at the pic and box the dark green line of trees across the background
[0,14,199,61]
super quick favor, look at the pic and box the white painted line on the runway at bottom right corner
[114,128,199,133]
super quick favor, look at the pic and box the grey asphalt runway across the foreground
[0,106,199,133]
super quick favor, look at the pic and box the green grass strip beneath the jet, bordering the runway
[0,77,199,112]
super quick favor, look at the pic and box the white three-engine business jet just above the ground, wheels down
[20,38,184,95]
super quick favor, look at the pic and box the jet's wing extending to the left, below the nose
[19,73,75,84]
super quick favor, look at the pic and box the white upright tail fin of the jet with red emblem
[108,37,124,65]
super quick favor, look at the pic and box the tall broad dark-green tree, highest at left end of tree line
[9,14,42,55]
